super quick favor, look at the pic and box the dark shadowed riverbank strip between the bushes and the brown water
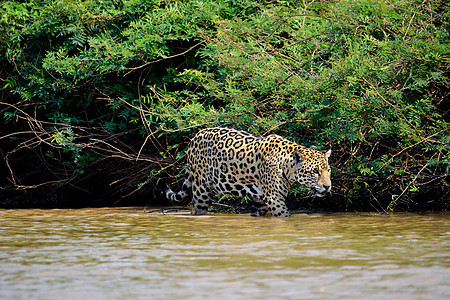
[0,183,450,214]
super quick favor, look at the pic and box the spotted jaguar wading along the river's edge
[157,127,331,217]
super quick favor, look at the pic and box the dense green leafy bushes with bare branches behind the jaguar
[0,0,450,211]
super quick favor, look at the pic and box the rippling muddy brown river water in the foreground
[0,208,450,300]
